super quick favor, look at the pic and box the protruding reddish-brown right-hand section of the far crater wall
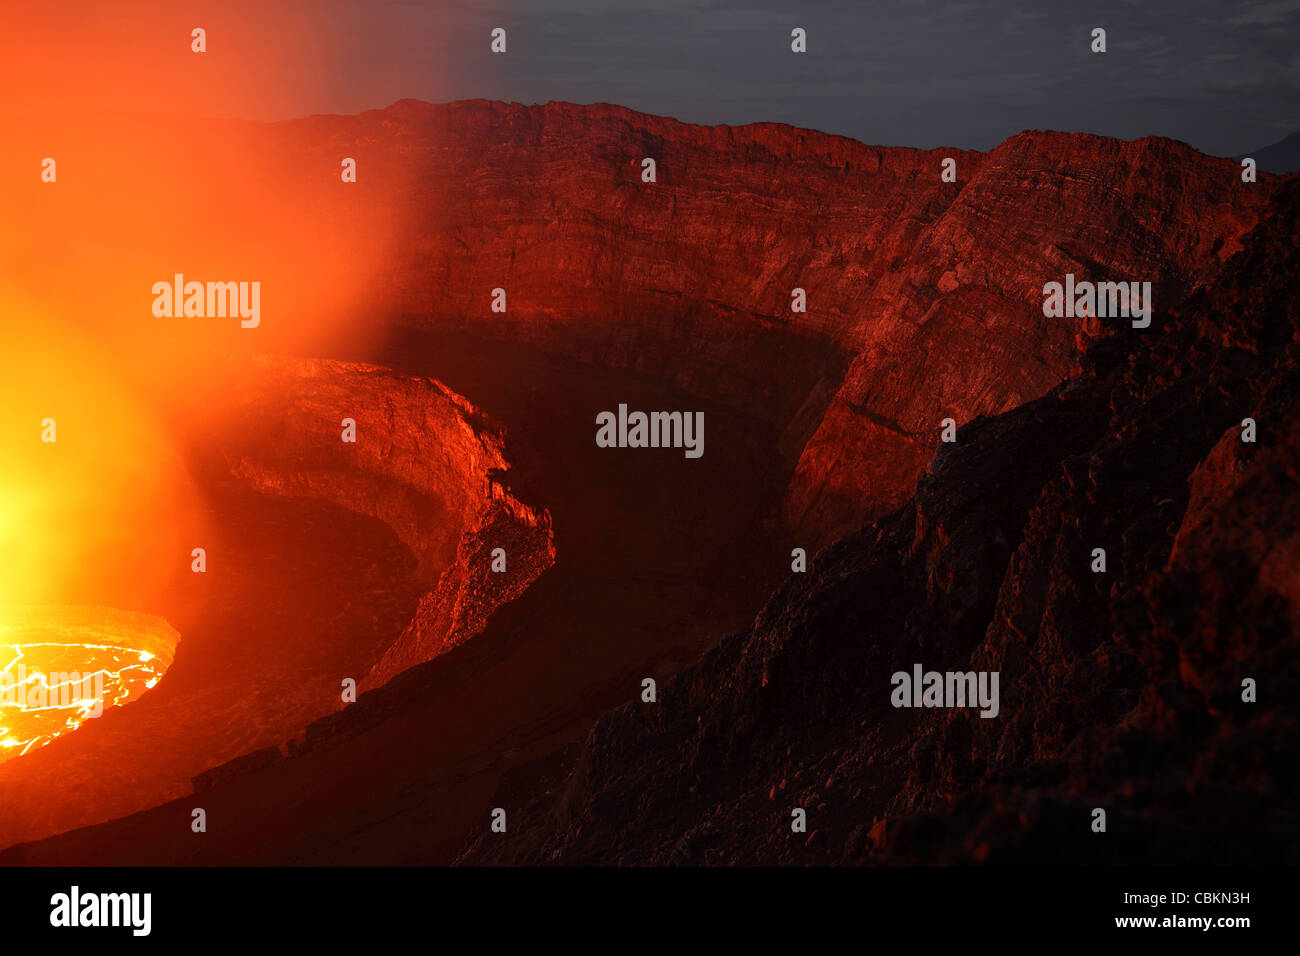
[787,133,1271,540]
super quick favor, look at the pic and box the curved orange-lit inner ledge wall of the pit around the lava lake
[211,358,555,688]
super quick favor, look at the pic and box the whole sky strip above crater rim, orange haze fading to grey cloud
[20,0,1300,155]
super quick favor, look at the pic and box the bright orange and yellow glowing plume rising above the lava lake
[0,0,421,610]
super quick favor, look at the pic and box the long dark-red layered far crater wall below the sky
[283,100,1275,545]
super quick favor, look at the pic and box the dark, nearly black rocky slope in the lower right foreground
[464,183,1300,864]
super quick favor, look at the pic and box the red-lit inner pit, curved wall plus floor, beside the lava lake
[0,359,554,845]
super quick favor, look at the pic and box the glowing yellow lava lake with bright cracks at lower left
[0,605,181,763]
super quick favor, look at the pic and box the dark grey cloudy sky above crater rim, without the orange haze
[317,0,1300,155]
